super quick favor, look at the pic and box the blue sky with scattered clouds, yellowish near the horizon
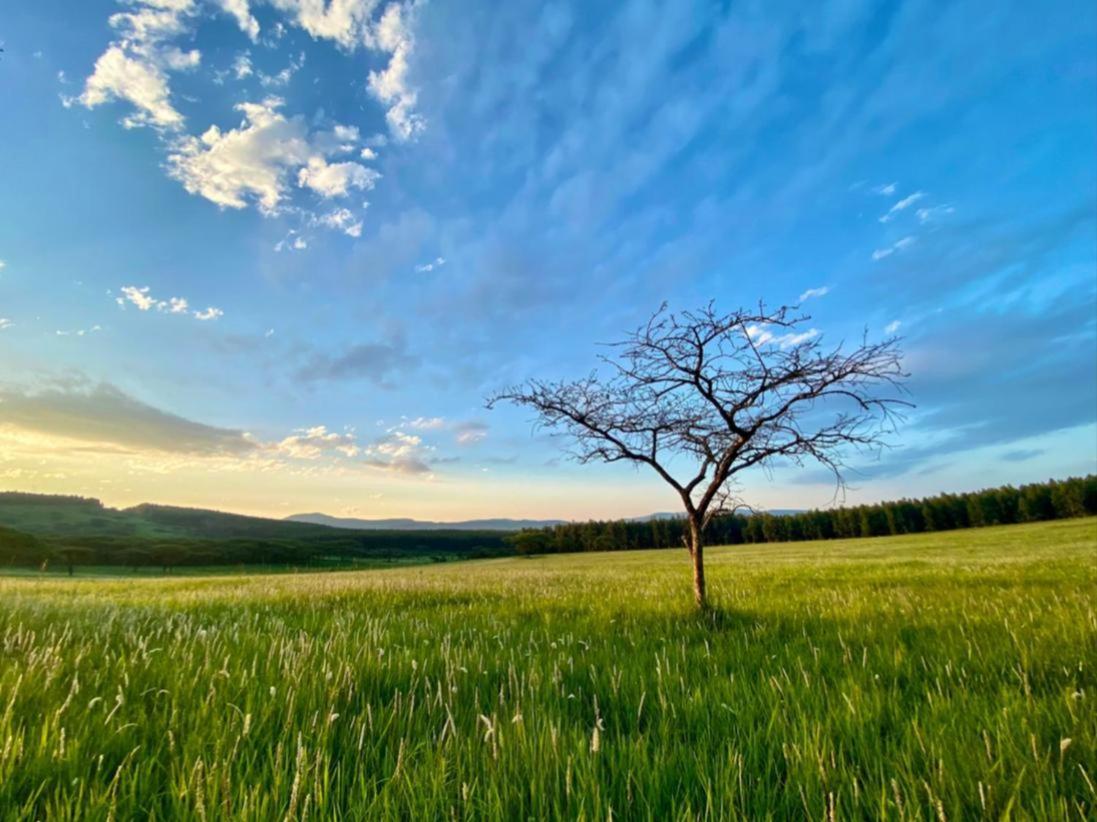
[0,0,1097,519]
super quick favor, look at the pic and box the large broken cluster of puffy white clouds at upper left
[72,0,423,224]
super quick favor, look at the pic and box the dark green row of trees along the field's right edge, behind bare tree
[506,474,1097,554]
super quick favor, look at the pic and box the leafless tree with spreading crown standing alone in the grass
[487,303,908,608]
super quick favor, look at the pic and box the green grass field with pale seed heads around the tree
[0,519,1097,820]
